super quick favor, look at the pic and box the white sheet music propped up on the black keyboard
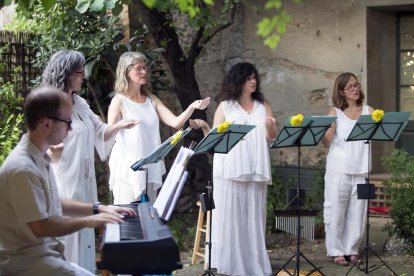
[153,147,194,221]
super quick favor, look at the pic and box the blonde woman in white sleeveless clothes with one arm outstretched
[108,52,210,204]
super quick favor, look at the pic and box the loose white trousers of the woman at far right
[323,170,367,257]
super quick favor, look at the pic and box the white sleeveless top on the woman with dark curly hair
[213,101,272,184]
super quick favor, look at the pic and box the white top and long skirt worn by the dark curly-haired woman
[211,101,272,276]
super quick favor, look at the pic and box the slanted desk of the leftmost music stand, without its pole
[131,127,191,171]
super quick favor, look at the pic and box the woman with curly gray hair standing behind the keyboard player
[42,50,137,273]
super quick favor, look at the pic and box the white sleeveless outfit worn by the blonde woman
[109,94,165,204]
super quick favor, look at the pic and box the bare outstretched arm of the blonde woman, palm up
[152,95,210,129]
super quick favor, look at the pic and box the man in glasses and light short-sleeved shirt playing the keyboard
[0,86,136,275]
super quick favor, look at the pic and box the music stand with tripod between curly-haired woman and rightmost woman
[270,116,336,276]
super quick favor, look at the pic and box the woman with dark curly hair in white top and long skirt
[191,62,276,276]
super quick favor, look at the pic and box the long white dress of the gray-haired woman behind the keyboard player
[52,95,110,273]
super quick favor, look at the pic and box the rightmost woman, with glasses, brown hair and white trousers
[322,73,374,266]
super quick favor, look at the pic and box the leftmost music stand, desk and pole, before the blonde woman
[131,127,191,203]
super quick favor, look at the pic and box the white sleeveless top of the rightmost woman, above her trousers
[326,105,371,174]
